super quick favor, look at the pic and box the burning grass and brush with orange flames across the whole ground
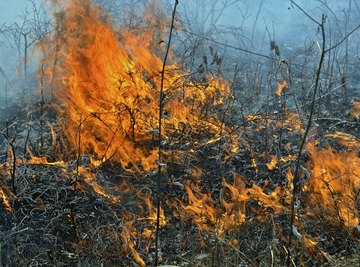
[0,0,360,266]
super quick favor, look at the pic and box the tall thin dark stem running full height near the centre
[154,0,179,266]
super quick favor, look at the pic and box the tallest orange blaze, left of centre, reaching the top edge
[46,0,230,172]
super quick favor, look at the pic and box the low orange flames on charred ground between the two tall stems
[170,174,290,237]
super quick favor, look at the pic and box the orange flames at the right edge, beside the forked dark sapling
[308,145,360,228]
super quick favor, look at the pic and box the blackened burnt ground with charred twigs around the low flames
[0,99,360,266]
